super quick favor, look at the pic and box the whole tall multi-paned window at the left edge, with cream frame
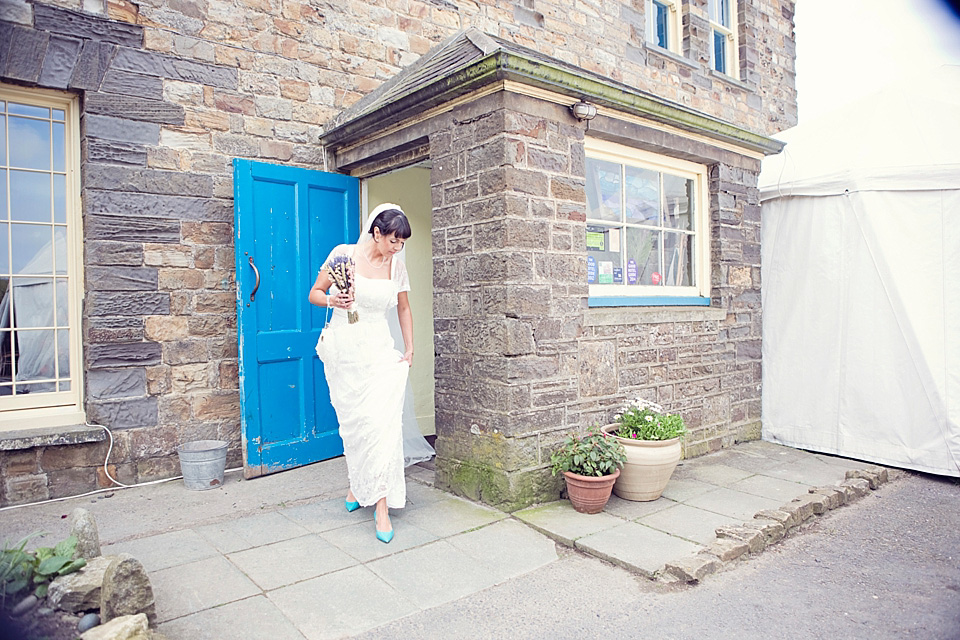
[0,86,82,427]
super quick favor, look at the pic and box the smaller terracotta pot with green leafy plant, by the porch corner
[550,427,626,513]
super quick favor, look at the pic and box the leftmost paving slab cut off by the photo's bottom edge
[159,595,304,640]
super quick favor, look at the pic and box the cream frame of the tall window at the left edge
[0,83,86,431]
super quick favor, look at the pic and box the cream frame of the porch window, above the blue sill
[584,138,710,306]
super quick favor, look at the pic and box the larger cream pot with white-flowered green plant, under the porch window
[603,398,687,502]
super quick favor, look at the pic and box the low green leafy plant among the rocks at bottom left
[0,532,87,607]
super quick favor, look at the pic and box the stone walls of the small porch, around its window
[430,93,761,509]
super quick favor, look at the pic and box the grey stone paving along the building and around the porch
[4,442,886,640]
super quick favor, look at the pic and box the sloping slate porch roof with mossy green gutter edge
[320,27,783,154]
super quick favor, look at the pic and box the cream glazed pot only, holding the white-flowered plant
[603,424,681,502]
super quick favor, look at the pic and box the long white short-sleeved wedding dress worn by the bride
[317,245,410,509]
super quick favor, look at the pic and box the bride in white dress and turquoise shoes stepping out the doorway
[309,204,433,542]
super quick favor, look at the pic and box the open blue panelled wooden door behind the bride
[233,159,360,478]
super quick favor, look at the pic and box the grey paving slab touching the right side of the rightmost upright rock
[150,555,260,622]
